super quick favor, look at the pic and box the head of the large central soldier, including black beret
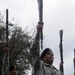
[40,48,54,65]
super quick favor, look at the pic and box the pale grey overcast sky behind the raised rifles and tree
[0,0,75,75]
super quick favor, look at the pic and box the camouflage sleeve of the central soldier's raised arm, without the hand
[30,33,39,66]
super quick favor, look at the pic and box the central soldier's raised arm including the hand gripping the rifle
[30,22,43,66]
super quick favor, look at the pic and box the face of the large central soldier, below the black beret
[43,51,54,65]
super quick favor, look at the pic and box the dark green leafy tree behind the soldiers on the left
[0,25,31,75]
